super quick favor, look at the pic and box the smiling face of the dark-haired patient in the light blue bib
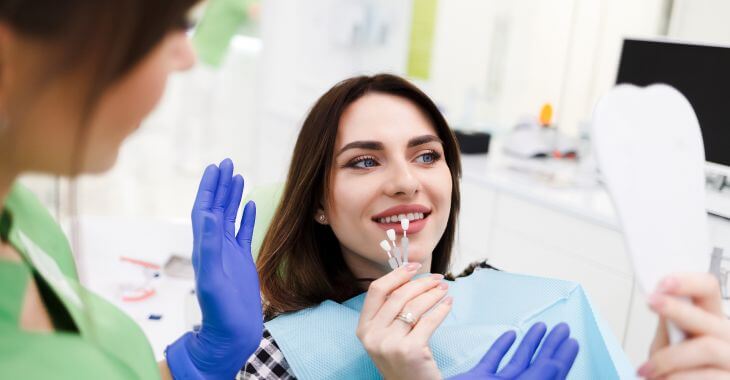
[323,93,452,278]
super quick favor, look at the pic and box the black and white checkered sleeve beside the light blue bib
[236,329,296,380]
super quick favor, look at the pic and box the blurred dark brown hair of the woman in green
[0,0,199,117]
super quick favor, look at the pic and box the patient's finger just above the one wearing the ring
[370,274,444,327]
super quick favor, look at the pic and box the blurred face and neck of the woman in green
[2,30,195,175]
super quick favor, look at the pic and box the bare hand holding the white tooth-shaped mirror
[639,273,730,379]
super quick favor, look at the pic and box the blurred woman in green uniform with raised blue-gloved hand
[0,0,263,379]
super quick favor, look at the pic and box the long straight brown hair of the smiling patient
[257,74,461,318]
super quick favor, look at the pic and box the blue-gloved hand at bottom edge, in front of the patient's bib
[450,322,578,380]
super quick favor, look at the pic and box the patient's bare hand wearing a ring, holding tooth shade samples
[357,263,452,379]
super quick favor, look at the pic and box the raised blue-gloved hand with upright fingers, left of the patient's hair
[166,159,263,380]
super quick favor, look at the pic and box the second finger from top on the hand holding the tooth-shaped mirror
[649,293,730,341]
